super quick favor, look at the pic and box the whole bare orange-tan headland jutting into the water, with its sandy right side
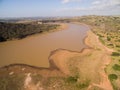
[49,31,113,90]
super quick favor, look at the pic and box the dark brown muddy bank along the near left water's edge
[0,64,64,77]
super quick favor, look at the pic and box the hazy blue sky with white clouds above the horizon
[0,0,120,17]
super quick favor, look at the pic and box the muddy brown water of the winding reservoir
[0,24,89,67]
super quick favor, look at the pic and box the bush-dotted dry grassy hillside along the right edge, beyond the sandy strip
[74,16,120,90]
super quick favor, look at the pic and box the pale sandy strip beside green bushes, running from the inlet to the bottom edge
[86,32,113,90]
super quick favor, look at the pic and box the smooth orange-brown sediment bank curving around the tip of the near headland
[49,49,92,75]
